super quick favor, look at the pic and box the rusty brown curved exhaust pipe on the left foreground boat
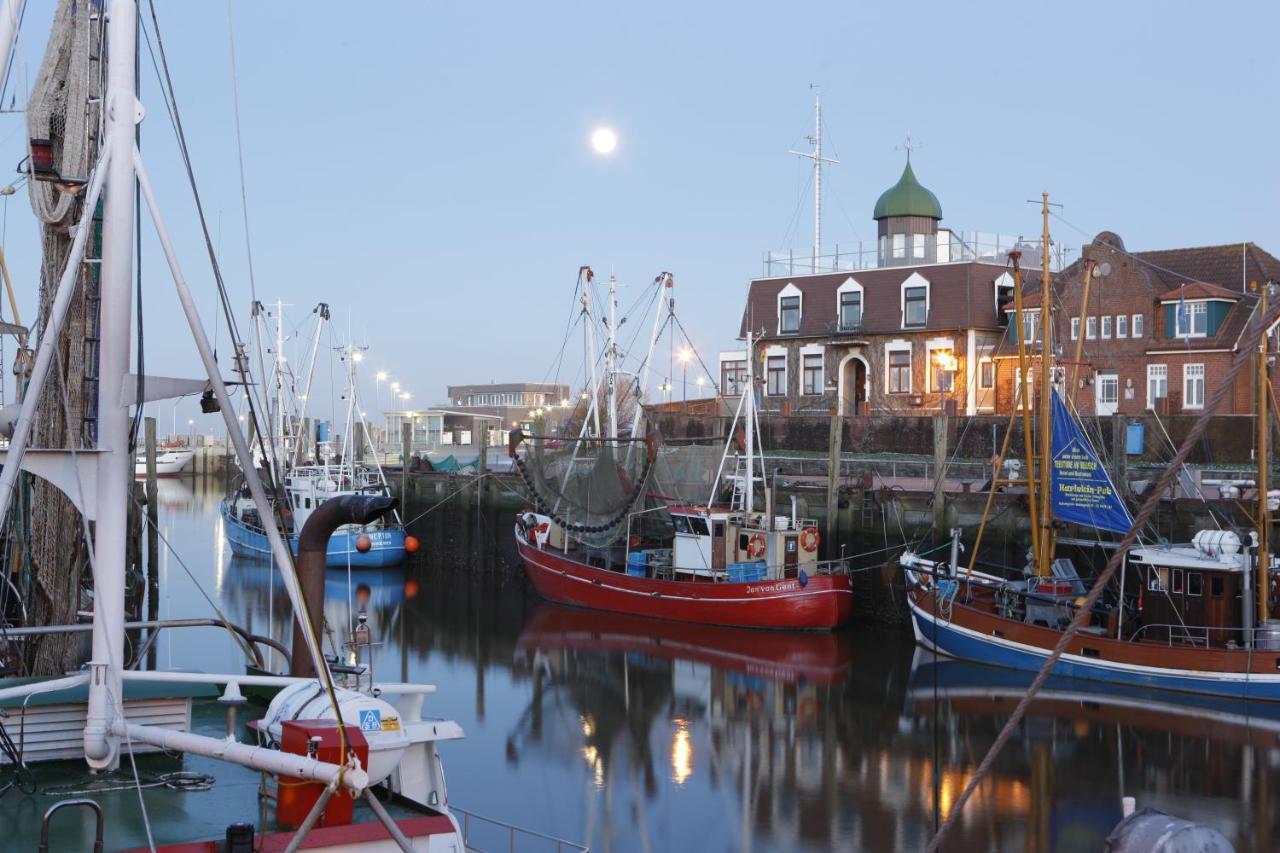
[289,494,399,678]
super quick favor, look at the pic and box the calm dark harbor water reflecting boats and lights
[135,478,1280,853]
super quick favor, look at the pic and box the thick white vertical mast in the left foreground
[84,0,142,770]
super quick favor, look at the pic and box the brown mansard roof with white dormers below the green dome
[739,261,1007,338]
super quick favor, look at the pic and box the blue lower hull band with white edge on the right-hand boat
[911,602,1280,702]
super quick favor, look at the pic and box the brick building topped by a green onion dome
[721,161,1034,415]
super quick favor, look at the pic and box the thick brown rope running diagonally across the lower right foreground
[927,290,1280,853]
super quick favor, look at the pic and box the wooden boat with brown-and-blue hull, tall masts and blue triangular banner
[900,195,1280,701]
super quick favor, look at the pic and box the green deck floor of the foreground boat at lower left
[0,699,448,850]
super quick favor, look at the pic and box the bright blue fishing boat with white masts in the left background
[220,302,417,569]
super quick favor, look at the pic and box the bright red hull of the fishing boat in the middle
[516,535,854,630]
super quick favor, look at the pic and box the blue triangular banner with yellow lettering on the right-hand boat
[1050,391,1133,533]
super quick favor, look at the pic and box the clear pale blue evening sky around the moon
[0,0,1280,434]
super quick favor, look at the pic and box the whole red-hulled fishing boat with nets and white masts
[508,268,852,630]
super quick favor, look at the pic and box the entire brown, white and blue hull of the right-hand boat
[909,585,1280,702]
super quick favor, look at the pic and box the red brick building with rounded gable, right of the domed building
[995,232,1280,415]
